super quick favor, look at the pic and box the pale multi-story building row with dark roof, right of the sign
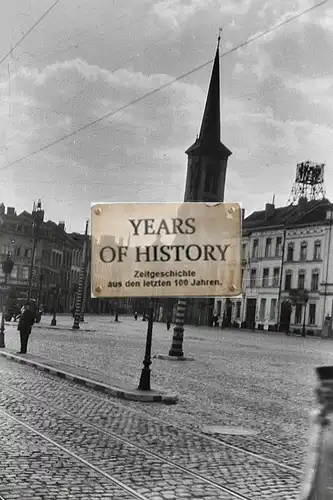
[215,199,333,335]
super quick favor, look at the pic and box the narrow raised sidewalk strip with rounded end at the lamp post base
[0,349,178,404]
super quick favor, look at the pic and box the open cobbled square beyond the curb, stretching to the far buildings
[6,316,333,490]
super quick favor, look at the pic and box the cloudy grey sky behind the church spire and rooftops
[0,0,333,232]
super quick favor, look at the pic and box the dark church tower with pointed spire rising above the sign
[184,37,232,202]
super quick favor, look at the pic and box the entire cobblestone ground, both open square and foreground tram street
[0,316,333,500]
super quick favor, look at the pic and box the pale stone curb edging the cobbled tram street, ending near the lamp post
[0,350,179,405]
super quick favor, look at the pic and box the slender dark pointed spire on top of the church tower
[199,29,222,145]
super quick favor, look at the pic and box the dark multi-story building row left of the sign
[0,204,82,311]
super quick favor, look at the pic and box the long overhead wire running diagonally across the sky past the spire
[0,0,330,171]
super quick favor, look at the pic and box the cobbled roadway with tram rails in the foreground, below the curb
[0,358,299,500]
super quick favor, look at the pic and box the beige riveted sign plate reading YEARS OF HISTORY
[91,203,241,298]
